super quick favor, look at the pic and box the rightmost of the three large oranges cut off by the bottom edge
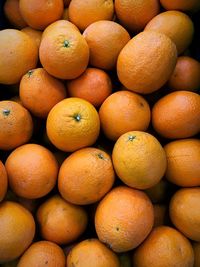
[133,226,194,267]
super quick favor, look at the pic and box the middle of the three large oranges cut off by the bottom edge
[66,239,120,267]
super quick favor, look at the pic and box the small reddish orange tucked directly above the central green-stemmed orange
[67,68,112,107]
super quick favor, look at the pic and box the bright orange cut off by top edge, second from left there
[19,0,64,30]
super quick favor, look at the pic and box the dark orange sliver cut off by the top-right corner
[160,0,200,11]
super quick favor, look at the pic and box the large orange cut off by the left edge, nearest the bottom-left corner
[0,201,35,263]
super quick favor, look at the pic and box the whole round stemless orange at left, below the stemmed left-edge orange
[5,144,58,199]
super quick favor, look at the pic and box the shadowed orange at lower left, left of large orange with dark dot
[37,195,87,244]
